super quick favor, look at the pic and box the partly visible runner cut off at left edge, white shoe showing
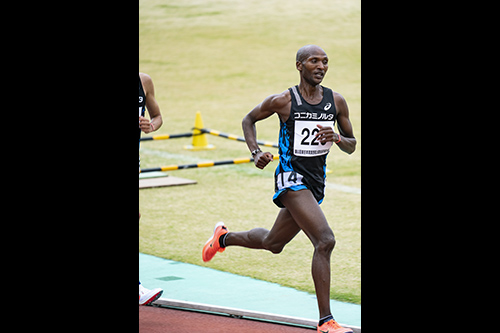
[139,73,163,305]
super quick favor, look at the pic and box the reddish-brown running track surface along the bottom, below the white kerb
[139,306,315,333]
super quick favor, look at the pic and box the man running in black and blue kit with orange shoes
[203,45,356,333]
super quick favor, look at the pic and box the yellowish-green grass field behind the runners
[139,0,362,304]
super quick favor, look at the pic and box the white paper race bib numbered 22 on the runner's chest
[293,120,335,157]
